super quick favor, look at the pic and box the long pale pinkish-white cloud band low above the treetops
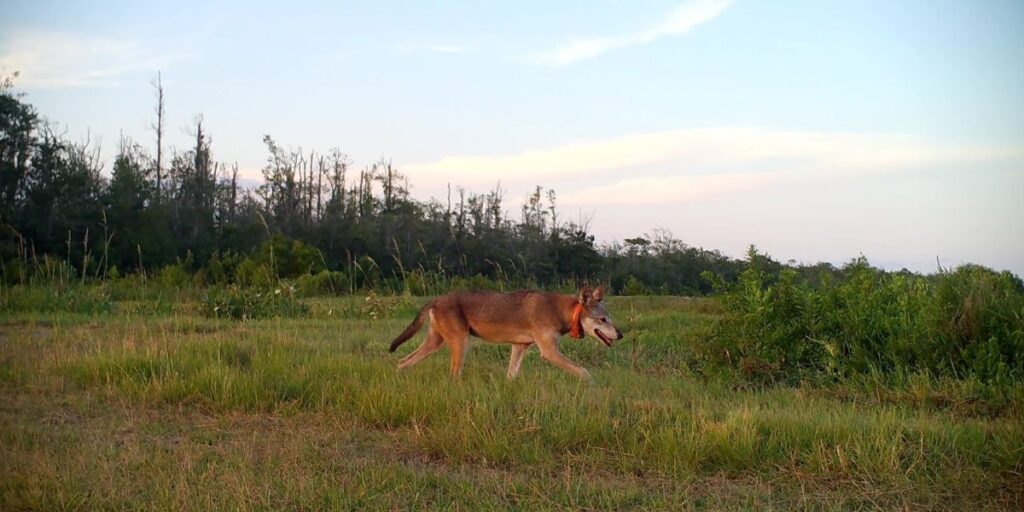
[401,128,1024,204]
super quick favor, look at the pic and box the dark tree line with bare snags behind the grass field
[0,75,872,294]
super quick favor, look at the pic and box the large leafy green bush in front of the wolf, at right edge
[710,249,1024,384]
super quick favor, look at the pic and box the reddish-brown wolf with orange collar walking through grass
[390,287,623,381]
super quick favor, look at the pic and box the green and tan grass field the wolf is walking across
[0,297,1024,510]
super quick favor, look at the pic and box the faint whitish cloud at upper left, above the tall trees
[0,31,179,88]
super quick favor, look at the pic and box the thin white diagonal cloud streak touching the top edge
[532,0,732,66]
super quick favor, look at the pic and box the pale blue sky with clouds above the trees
[0,0,1024,275]
